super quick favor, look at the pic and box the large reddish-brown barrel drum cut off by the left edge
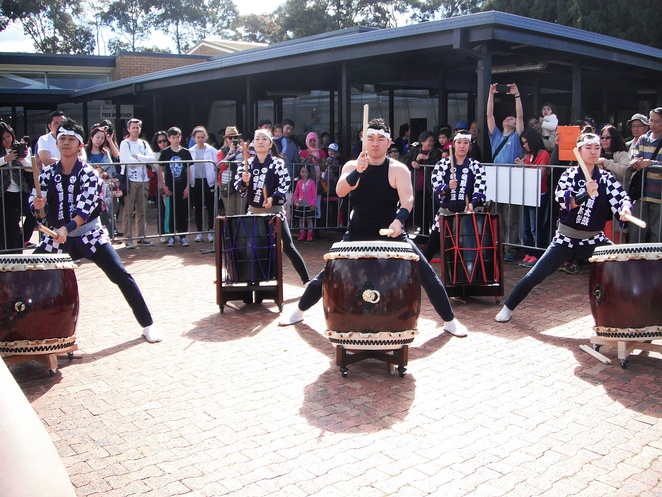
[0,254,78,355]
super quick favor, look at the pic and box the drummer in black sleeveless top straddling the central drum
[280,119,467,336]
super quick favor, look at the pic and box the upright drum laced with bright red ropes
[439,213,503,297]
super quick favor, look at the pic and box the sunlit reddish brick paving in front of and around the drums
[5,233,662,497]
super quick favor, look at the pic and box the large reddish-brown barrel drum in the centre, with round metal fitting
[322,241,421,334]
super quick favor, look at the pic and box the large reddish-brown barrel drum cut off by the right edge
[589,243,662,341]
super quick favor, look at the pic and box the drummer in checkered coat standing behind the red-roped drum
[422,130,487,261]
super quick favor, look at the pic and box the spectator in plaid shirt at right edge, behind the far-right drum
[628,107,662,243]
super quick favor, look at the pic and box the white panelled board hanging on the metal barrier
[485,165,541,207]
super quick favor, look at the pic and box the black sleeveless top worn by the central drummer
[345,158,400,241]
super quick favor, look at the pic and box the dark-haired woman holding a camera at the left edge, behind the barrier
[0,122,34,253]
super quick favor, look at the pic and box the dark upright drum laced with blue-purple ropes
[221,214,278,283]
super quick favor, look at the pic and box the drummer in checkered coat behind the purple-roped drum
[235,129,310,283]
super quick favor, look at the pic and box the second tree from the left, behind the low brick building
[101,0,156,53]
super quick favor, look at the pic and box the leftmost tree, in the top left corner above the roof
[0,0,95,54]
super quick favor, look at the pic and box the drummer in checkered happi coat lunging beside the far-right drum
[494,133,632,323]
